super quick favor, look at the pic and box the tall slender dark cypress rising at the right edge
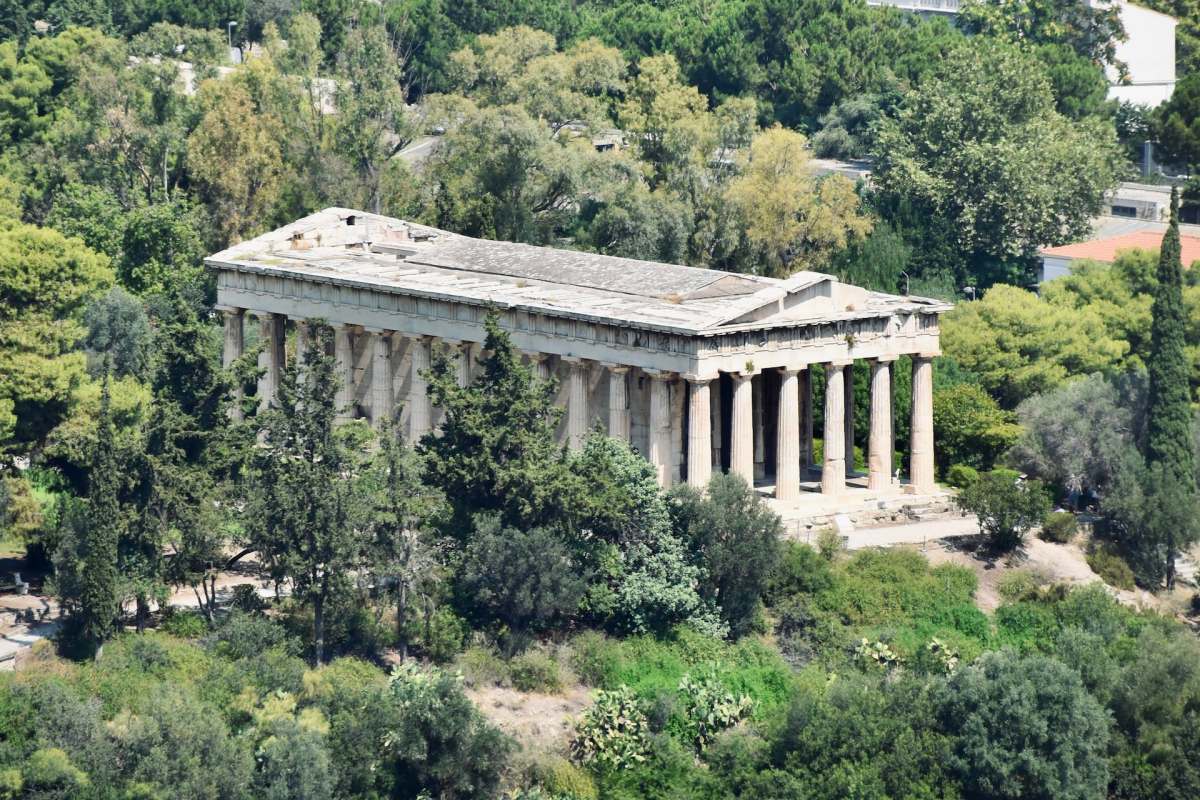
[1146,191,1196,588]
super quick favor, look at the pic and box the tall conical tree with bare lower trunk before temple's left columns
[246,325,366,663]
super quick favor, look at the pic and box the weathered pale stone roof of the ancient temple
[205,209,950,335]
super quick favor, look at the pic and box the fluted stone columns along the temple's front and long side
[224,309,934,500]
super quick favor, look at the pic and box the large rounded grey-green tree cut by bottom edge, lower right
[934,650,1109,800]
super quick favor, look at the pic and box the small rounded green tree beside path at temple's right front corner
[954,469,1050,553]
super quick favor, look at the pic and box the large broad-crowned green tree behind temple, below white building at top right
[872,38,1116,285]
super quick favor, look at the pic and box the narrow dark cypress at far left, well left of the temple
[78,372,121,658]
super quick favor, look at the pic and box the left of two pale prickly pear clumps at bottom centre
[571,686,649,770]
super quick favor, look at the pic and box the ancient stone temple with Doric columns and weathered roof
[206,209,949,501]
